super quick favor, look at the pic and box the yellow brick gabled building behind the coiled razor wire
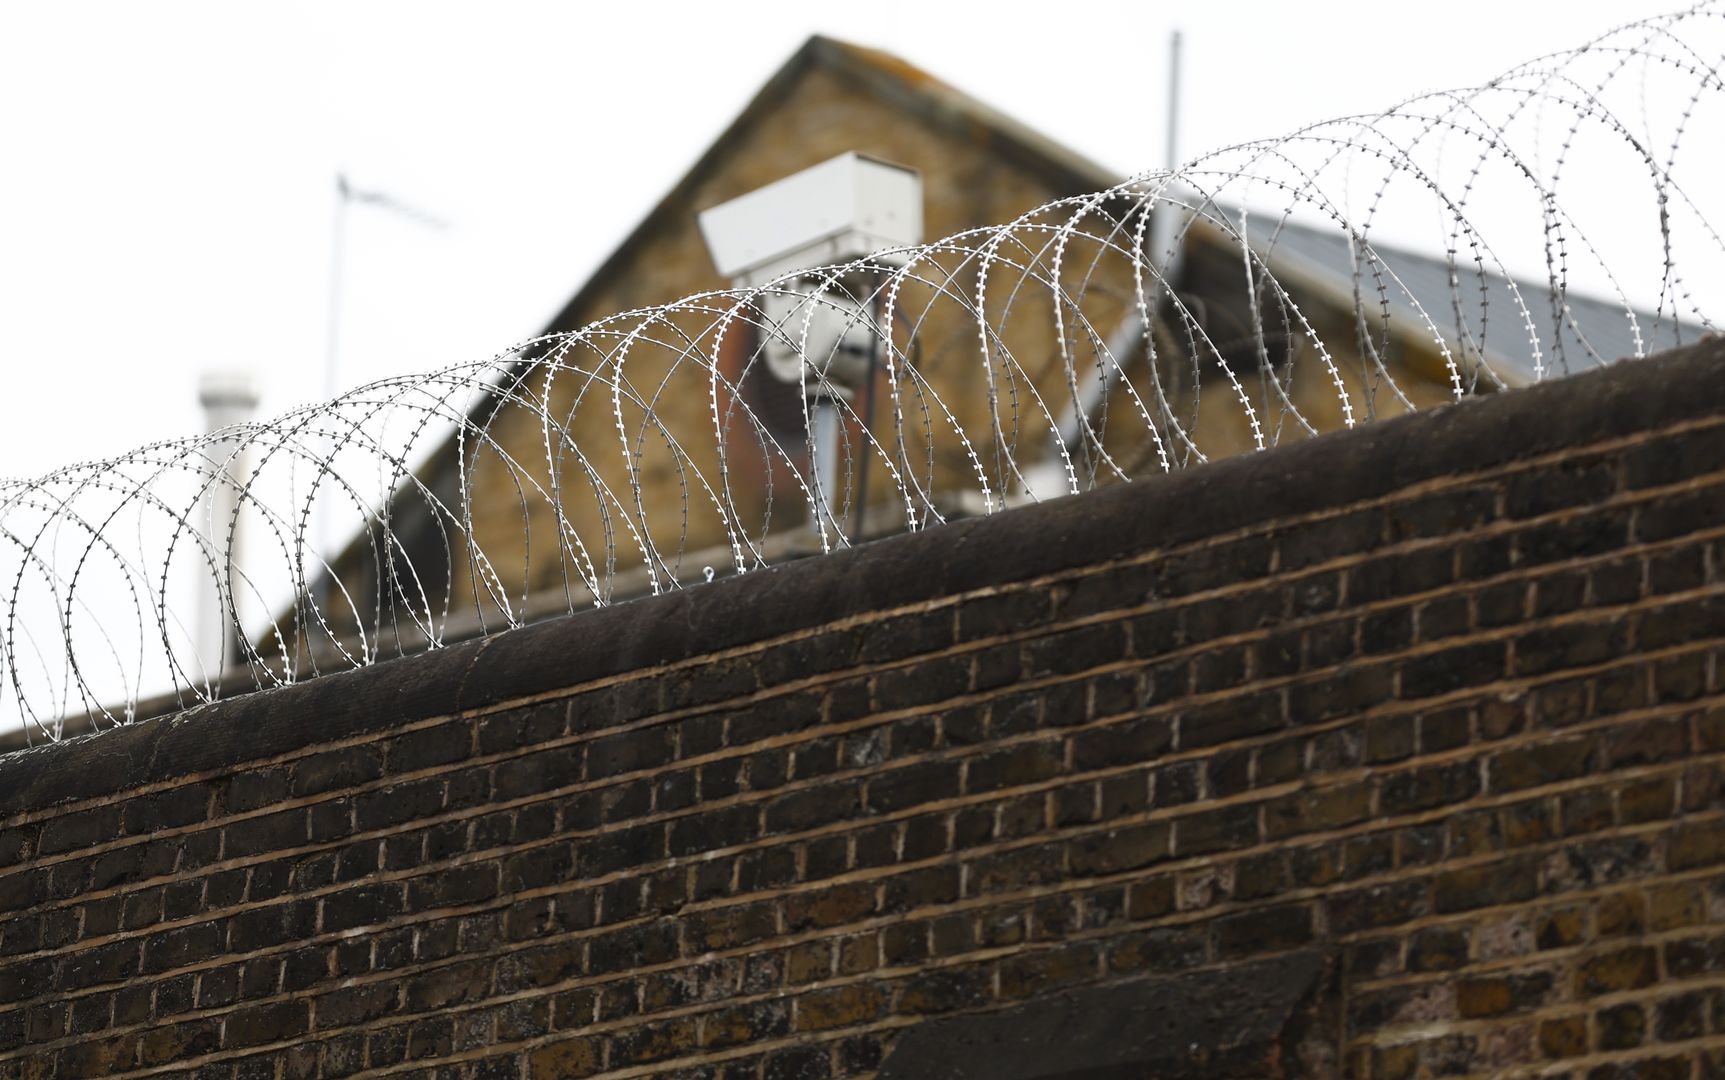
[286,38,1697,656]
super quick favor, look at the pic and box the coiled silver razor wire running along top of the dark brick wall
[0,3,1725,738]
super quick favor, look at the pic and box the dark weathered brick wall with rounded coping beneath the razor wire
[0,342,1725,1080]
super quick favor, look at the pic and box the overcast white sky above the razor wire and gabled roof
[0,0,1668,476]
